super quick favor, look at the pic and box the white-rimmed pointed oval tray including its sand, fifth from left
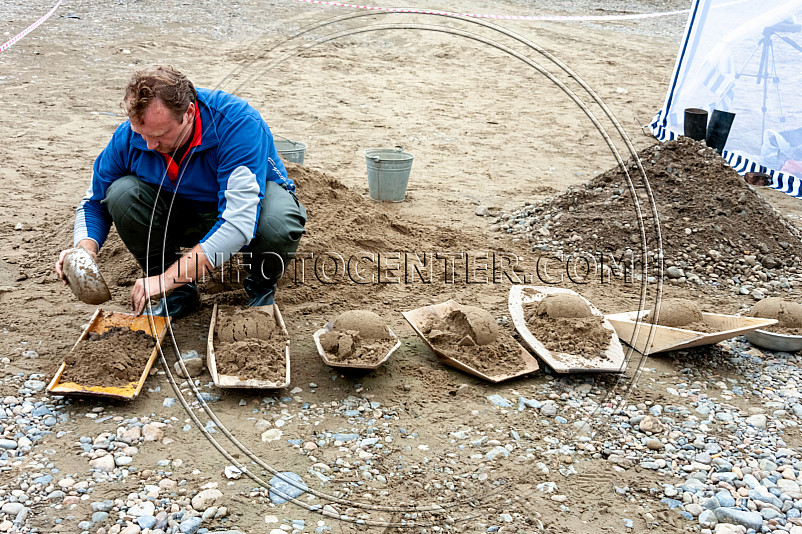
[508,285,626,373]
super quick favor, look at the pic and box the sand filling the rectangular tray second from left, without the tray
[214,306,287,383]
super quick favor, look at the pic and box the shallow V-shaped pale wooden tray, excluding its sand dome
[607,310,777,355]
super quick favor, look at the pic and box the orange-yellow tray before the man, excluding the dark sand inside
[47,308,170,400]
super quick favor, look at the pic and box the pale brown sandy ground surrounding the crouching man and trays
[0,0,798,532]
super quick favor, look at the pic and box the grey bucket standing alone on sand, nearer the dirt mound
[365,147,413,202]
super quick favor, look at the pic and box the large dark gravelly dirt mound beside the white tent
[504,137,802,279]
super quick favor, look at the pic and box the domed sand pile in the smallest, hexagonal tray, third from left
[320,310,396,365]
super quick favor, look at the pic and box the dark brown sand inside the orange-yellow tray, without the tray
[61,326,156,387]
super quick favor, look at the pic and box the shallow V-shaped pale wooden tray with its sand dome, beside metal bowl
[607,299,777,355]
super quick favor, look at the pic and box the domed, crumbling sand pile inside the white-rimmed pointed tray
[524,293,612,358]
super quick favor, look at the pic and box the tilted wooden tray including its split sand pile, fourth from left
[402,300,538,382]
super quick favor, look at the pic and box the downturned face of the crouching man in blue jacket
[131,99,195,154]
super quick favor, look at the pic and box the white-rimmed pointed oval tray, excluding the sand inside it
[508,285,626,373]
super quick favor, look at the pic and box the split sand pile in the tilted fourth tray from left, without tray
[421,306,526,376]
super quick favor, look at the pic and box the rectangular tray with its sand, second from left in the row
[206,304,290,389]
